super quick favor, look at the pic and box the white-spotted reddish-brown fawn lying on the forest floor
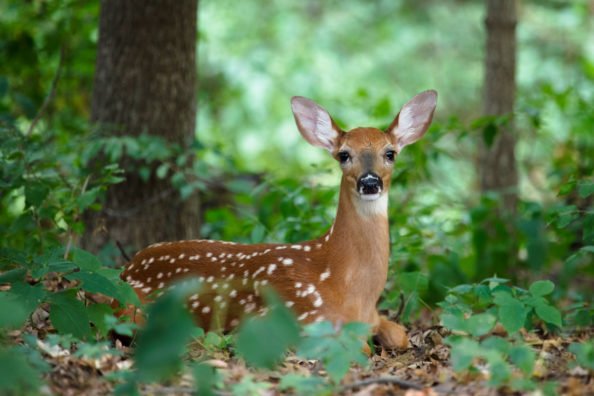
[122,91,437,348]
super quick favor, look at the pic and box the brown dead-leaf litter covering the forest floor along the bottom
[11,307,594,396]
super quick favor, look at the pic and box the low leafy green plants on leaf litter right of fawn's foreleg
[439,277,563,391]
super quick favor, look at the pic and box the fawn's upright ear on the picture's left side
[291,96,341,153]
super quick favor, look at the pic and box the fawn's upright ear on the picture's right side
[387,90,437,151]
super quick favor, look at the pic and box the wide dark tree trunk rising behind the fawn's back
[83,0,199,251]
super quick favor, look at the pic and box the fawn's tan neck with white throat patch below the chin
[324,179,390,294]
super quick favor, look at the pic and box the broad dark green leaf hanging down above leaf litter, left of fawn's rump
[49,289,92,339]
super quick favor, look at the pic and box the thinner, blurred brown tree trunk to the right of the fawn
[479,0,518,213]
